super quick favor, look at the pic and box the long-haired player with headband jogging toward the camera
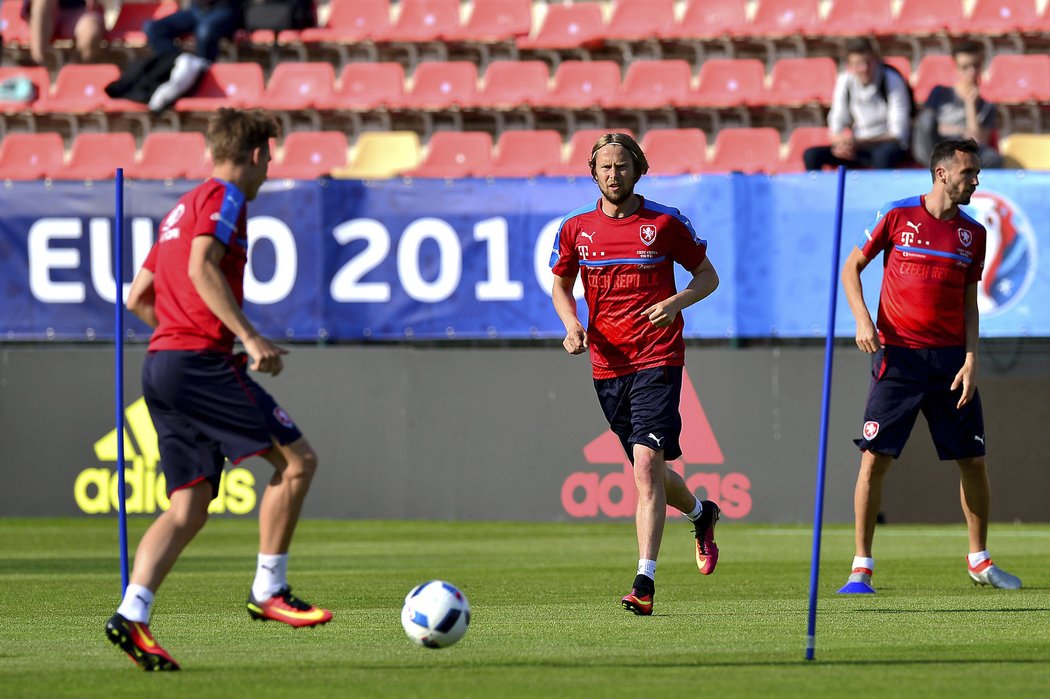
[550,133,719,615]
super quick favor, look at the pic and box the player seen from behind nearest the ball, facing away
[106,109,332,670]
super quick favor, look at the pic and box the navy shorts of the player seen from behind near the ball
[142,350,302,497]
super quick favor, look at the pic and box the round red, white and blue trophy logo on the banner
[967,192,1036,316]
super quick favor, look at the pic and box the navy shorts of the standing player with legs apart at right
[854,346,985,461]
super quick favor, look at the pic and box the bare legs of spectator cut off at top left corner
[22,0,106,65]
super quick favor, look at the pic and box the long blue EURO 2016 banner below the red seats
[0,170,1050,341]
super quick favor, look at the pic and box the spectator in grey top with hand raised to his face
[911,41,1003,169]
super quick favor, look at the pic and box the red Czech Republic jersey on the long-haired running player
[550,198,708,379]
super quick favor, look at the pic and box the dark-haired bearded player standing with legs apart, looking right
[840,139,1021,593]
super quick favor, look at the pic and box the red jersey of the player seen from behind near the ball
[143,178,248,353]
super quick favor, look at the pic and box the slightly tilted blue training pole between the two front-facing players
[805,166,846,660]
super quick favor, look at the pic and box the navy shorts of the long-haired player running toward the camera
[594,366,683,464]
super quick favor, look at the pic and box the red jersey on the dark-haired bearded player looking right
[861,196,986,348]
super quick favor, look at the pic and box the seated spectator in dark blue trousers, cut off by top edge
[143,0,244,63]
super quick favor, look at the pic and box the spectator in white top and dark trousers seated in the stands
[802,38,911,170]
